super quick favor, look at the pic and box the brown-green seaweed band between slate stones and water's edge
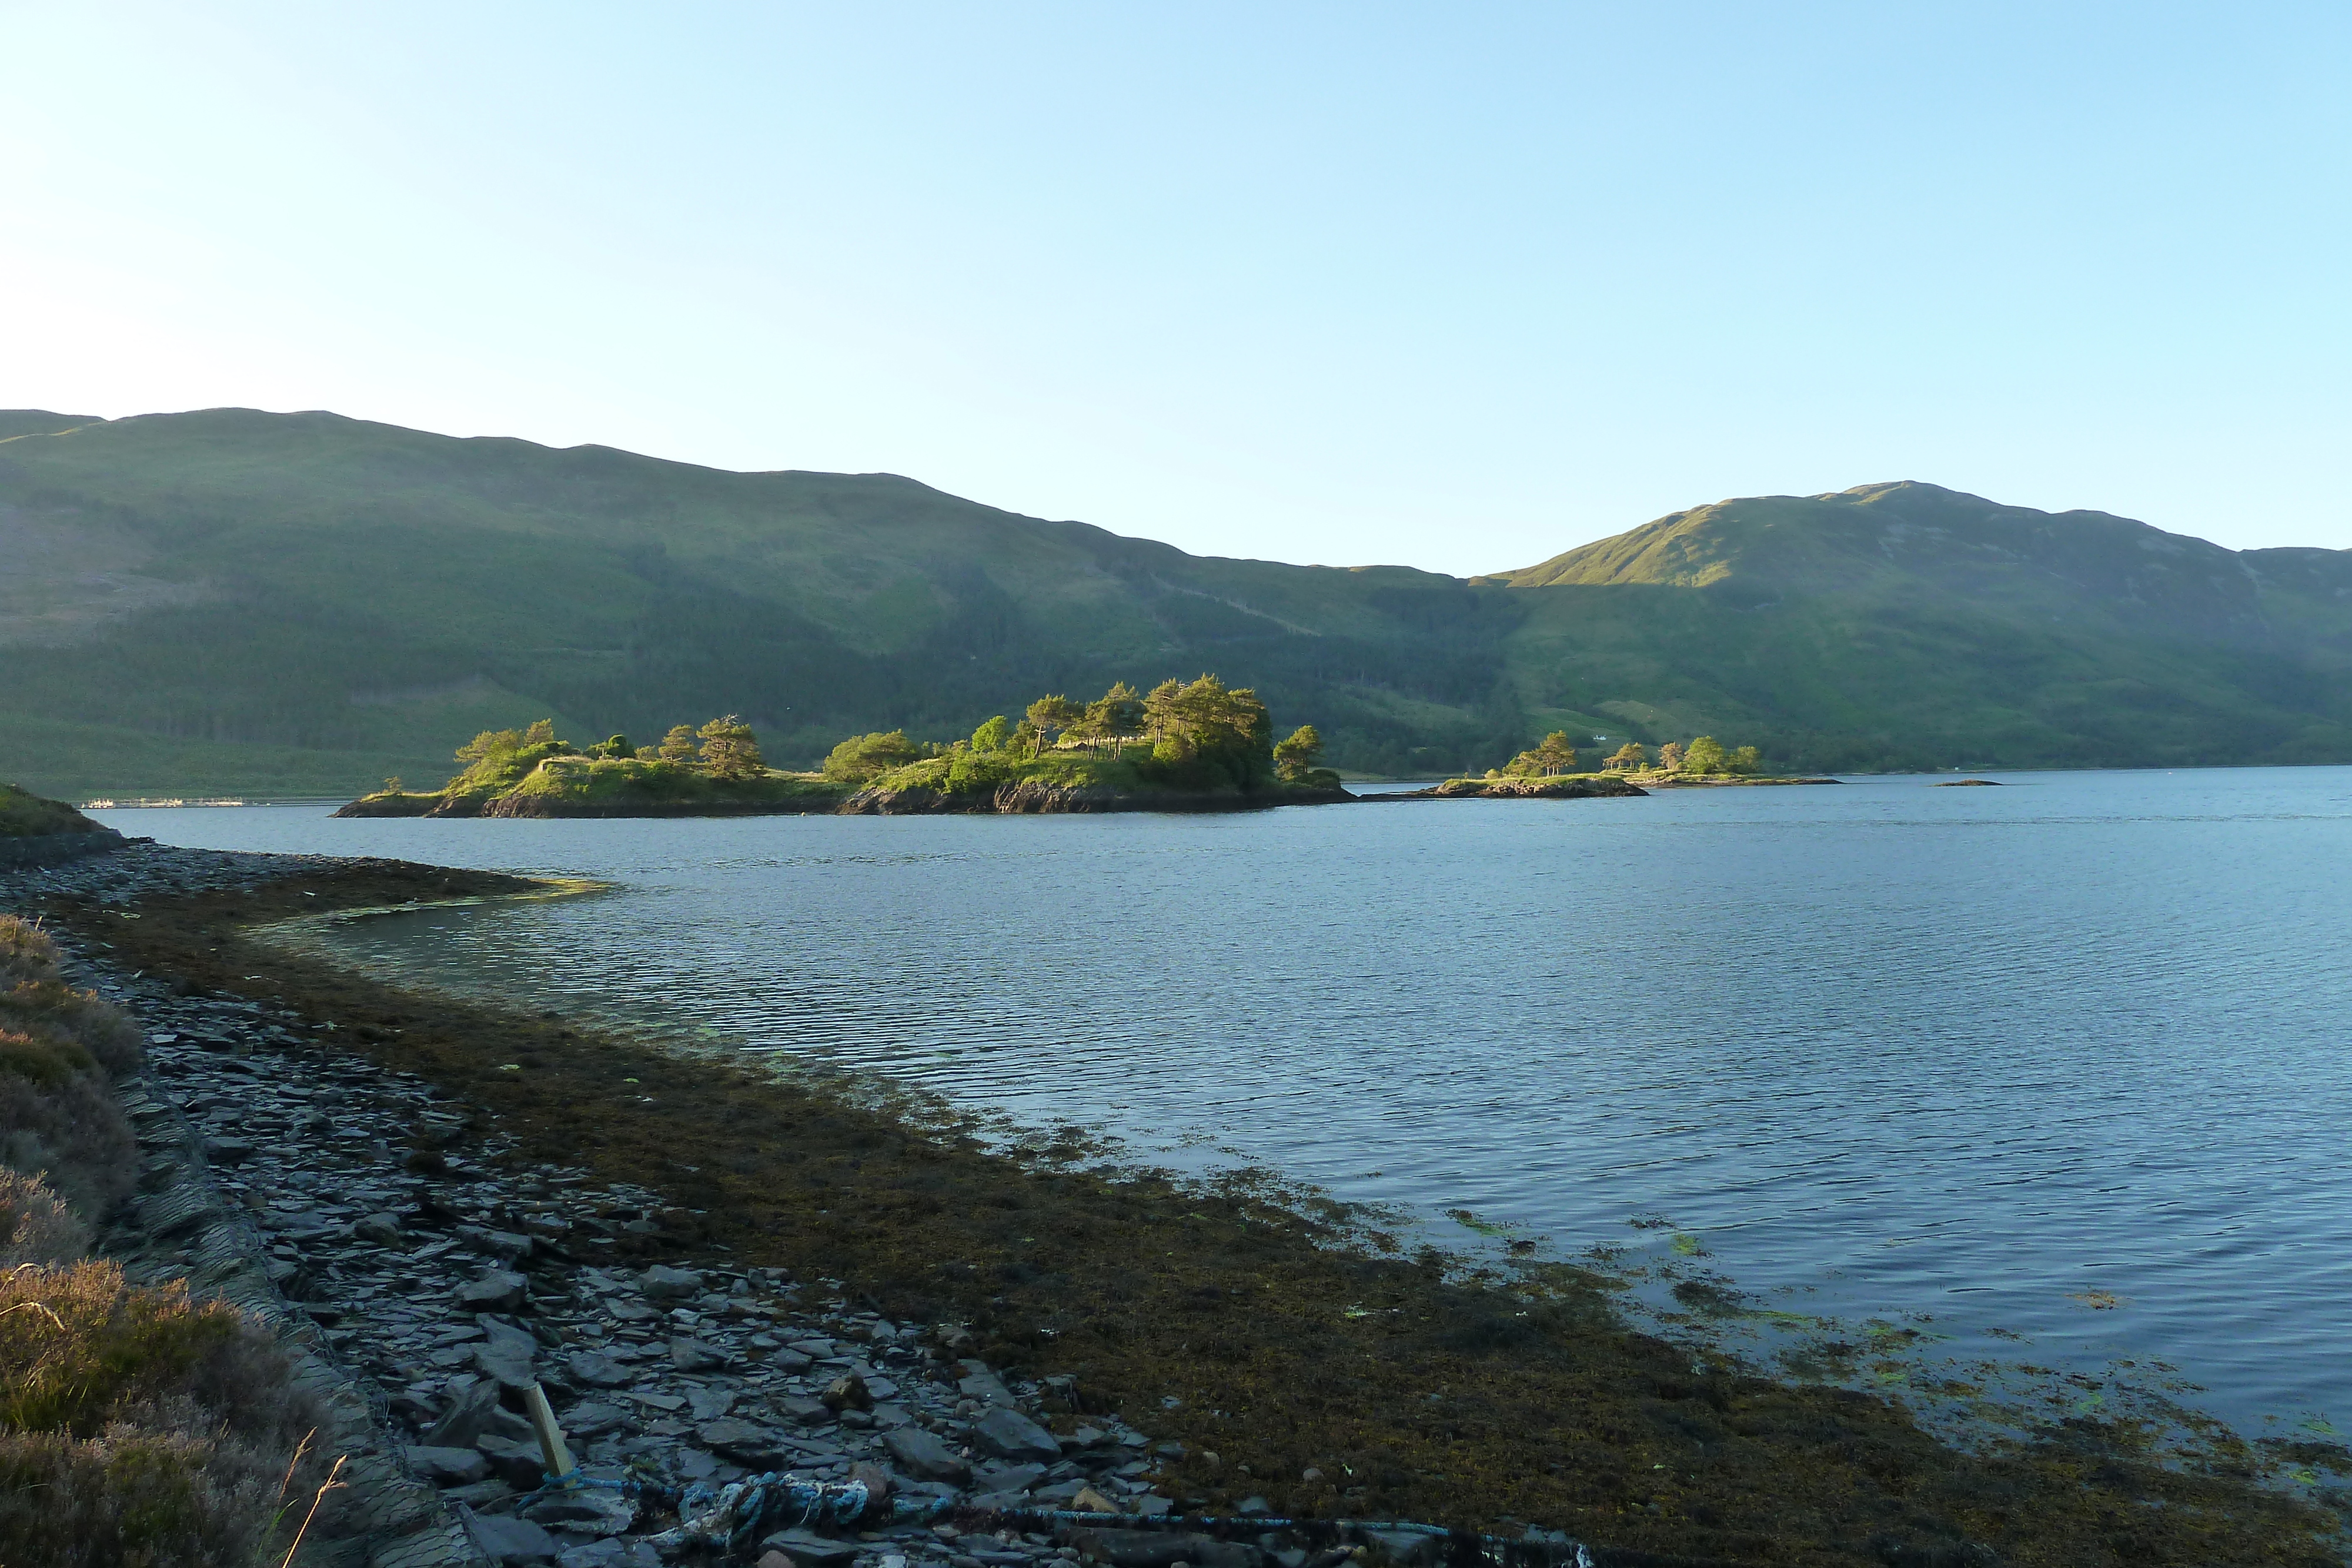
[59,862,2336,1568]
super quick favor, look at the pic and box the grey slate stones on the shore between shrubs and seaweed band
[14,846,1543,1568]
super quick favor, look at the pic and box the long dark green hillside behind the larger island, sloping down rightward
[0,412,1517,792]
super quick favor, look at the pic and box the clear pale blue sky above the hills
[0,0,2352,571]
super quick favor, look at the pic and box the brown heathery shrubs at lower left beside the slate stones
[0,914,320,1568]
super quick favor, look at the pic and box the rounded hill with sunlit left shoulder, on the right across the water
[1484,484,2352,769]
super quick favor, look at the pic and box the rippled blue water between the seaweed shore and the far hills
[106,769,2352,1420]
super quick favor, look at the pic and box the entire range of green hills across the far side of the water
[0,412,2352,794]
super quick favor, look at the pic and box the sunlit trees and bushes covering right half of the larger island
[823,675,1322,787]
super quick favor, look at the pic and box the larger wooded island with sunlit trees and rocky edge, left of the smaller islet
[336,675,1355,815]
